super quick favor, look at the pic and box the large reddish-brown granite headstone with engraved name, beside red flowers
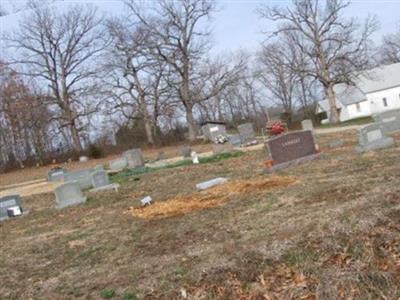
[266,130,319,170]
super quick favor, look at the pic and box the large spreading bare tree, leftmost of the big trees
[6,2,105,151]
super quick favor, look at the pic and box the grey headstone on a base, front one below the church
[356,122,394,152]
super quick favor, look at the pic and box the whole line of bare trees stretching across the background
[0,0,400,167]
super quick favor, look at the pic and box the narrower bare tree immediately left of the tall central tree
[108,20,163,145]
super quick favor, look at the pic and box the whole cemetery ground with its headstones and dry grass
[0,120,400,299]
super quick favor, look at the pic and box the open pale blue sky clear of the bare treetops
[0,0,400,53]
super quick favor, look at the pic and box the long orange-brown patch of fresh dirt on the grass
[128,177,295,219]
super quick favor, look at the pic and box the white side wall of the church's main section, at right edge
[367,86,400,114]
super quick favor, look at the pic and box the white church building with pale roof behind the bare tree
[317,63,400,123]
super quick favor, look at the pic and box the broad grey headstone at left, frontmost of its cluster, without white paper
[54,181,86,208]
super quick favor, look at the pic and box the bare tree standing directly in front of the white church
[260,0,377,123]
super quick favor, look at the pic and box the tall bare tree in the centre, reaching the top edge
[126,0,215,140]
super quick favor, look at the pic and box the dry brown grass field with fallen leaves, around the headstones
[0,131,400,300]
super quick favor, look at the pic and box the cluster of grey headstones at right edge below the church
[356,109,400,152]
